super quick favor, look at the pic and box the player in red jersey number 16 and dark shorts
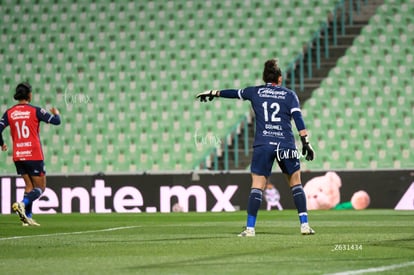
[0,82,60,226]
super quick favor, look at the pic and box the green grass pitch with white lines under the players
[0,210,414,275]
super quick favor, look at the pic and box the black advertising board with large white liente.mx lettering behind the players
[0,170,414,214]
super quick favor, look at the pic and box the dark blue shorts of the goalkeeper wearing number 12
[250,145,300,177]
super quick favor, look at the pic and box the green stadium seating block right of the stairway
[303,1,414,169]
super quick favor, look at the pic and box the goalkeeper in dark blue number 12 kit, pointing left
[196,59,315,237]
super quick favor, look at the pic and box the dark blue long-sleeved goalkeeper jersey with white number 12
[220,83,304,149]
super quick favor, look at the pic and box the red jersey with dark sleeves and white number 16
[0,104,60,161]
